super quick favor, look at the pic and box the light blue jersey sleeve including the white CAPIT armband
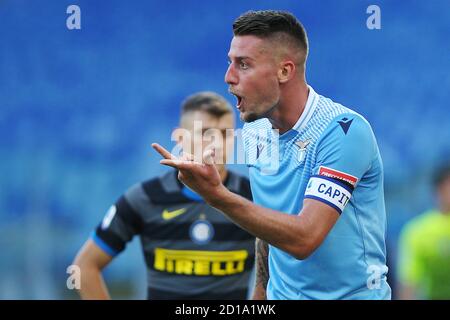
[305,114,378,214]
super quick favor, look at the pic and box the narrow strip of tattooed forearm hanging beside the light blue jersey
[253,238,269,300]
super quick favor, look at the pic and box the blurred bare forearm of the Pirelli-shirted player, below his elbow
[78,266,111,300]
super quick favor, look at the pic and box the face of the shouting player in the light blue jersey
[225,35,280,122]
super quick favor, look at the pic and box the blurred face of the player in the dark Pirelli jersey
[178,111,234,168]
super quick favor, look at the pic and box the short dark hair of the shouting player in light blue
[233,10,308,60]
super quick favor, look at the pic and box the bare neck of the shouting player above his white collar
[267,79,309,134]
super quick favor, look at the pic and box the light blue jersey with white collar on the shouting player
[243,87,391,299]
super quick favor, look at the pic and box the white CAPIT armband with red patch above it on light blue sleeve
[305,167,357,214]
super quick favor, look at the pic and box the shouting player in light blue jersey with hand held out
[153,11,391,299]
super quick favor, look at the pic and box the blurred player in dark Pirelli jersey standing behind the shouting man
[74,92,255,299]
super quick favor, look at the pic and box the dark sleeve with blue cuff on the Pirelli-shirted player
[92,186,142,256]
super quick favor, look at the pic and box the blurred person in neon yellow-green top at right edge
[398,164,450,299]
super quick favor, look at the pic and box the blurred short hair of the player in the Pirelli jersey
[181,91,233,118]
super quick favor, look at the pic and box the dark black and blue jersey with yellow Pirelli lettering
[93,171,255,299]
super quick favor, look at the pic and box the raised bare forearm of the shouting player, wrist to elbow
[205,187,311,259]
